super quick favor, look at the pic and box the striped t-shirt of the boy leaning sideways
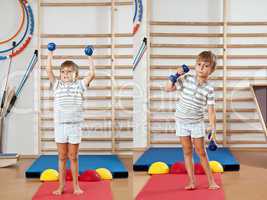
[175,74,215,122]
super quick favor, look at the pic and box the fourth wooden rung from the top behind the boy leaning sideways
[150,54,267,59]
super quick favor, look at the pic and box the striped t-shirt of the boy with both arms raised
[53,80,86,123]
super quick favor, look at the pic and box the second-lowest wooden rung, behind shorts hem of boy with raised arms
[41,137,133,142]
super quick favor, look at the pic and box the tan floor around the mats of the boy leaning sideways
[133,151,267,200]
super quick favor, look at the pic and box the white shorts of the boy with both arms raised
[55,123,82,144]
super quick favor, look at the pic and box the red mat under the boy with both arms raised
[32,181,112,200]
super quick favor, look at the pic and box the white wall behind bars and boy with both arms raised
[0,0,132,155]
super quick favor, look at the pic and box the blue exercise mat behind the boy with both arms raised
[25,155,128,178]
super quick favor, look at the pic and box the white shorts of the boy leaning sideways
[176,119,206,138]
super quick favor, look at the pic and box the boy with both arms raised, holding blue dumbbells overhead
[46,43,95,195]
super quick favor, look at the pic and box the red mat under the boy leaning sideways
[136,174,224,200]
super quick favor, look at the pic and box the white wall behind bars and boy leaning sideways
[134,0,267,148]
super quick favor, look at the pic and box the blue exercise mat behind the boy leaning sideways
[134,147,240,171]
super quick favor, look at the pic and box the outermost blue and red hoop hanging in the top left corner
[0,0,34,60]
